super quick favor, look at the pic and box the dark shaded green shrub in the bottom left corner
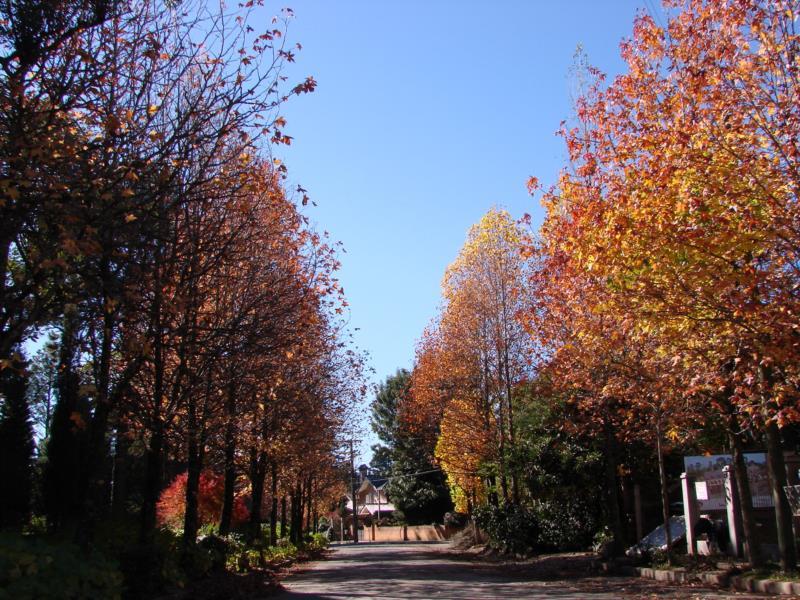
[0,535,123,600]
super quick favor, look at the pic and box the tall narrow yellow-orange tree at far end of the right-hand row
[407,209,533,506]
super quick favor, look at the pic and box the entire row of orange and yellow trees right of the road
[406,0,800,570]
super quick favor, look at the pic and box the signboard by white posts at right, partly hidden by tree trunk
[683,452,772,512]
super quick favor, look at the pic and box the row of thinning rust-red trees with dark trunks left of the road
[0,0,364,596]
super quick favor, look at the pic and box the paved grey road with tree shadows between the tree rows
[278,543,763,600]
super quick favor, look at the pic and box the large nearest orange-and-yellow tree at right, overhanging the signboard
[532,0,798,569]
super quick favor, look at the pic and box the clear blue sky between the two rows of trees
[265,0,657,460]
